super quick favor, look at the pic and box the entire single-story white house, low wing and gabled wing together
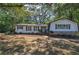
[15,19,78,34]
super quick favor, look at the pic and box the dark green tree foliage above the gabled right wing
[53,3,79,22]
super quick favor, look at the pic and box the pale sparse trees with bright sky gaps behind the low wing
[25,3,53,24]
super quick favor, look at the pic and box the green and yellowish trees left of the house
[0,4,29,32]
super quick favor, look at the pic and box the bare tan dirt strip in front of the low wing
[9,34,48,41]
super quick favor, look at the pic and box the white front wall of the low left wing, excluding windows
[15,24,48,33]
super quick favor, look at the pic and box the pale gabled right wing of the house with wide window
[49,19,78,34]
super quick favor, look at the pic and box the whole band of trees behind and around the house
[0,3,79,33]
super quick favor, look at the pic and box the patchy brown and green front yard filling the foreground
[0,35,79,55]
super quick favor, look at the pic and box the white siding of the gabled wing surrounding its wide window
[50,19,78,32]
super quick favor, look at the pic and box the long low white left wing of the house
[15,24,48,33]
